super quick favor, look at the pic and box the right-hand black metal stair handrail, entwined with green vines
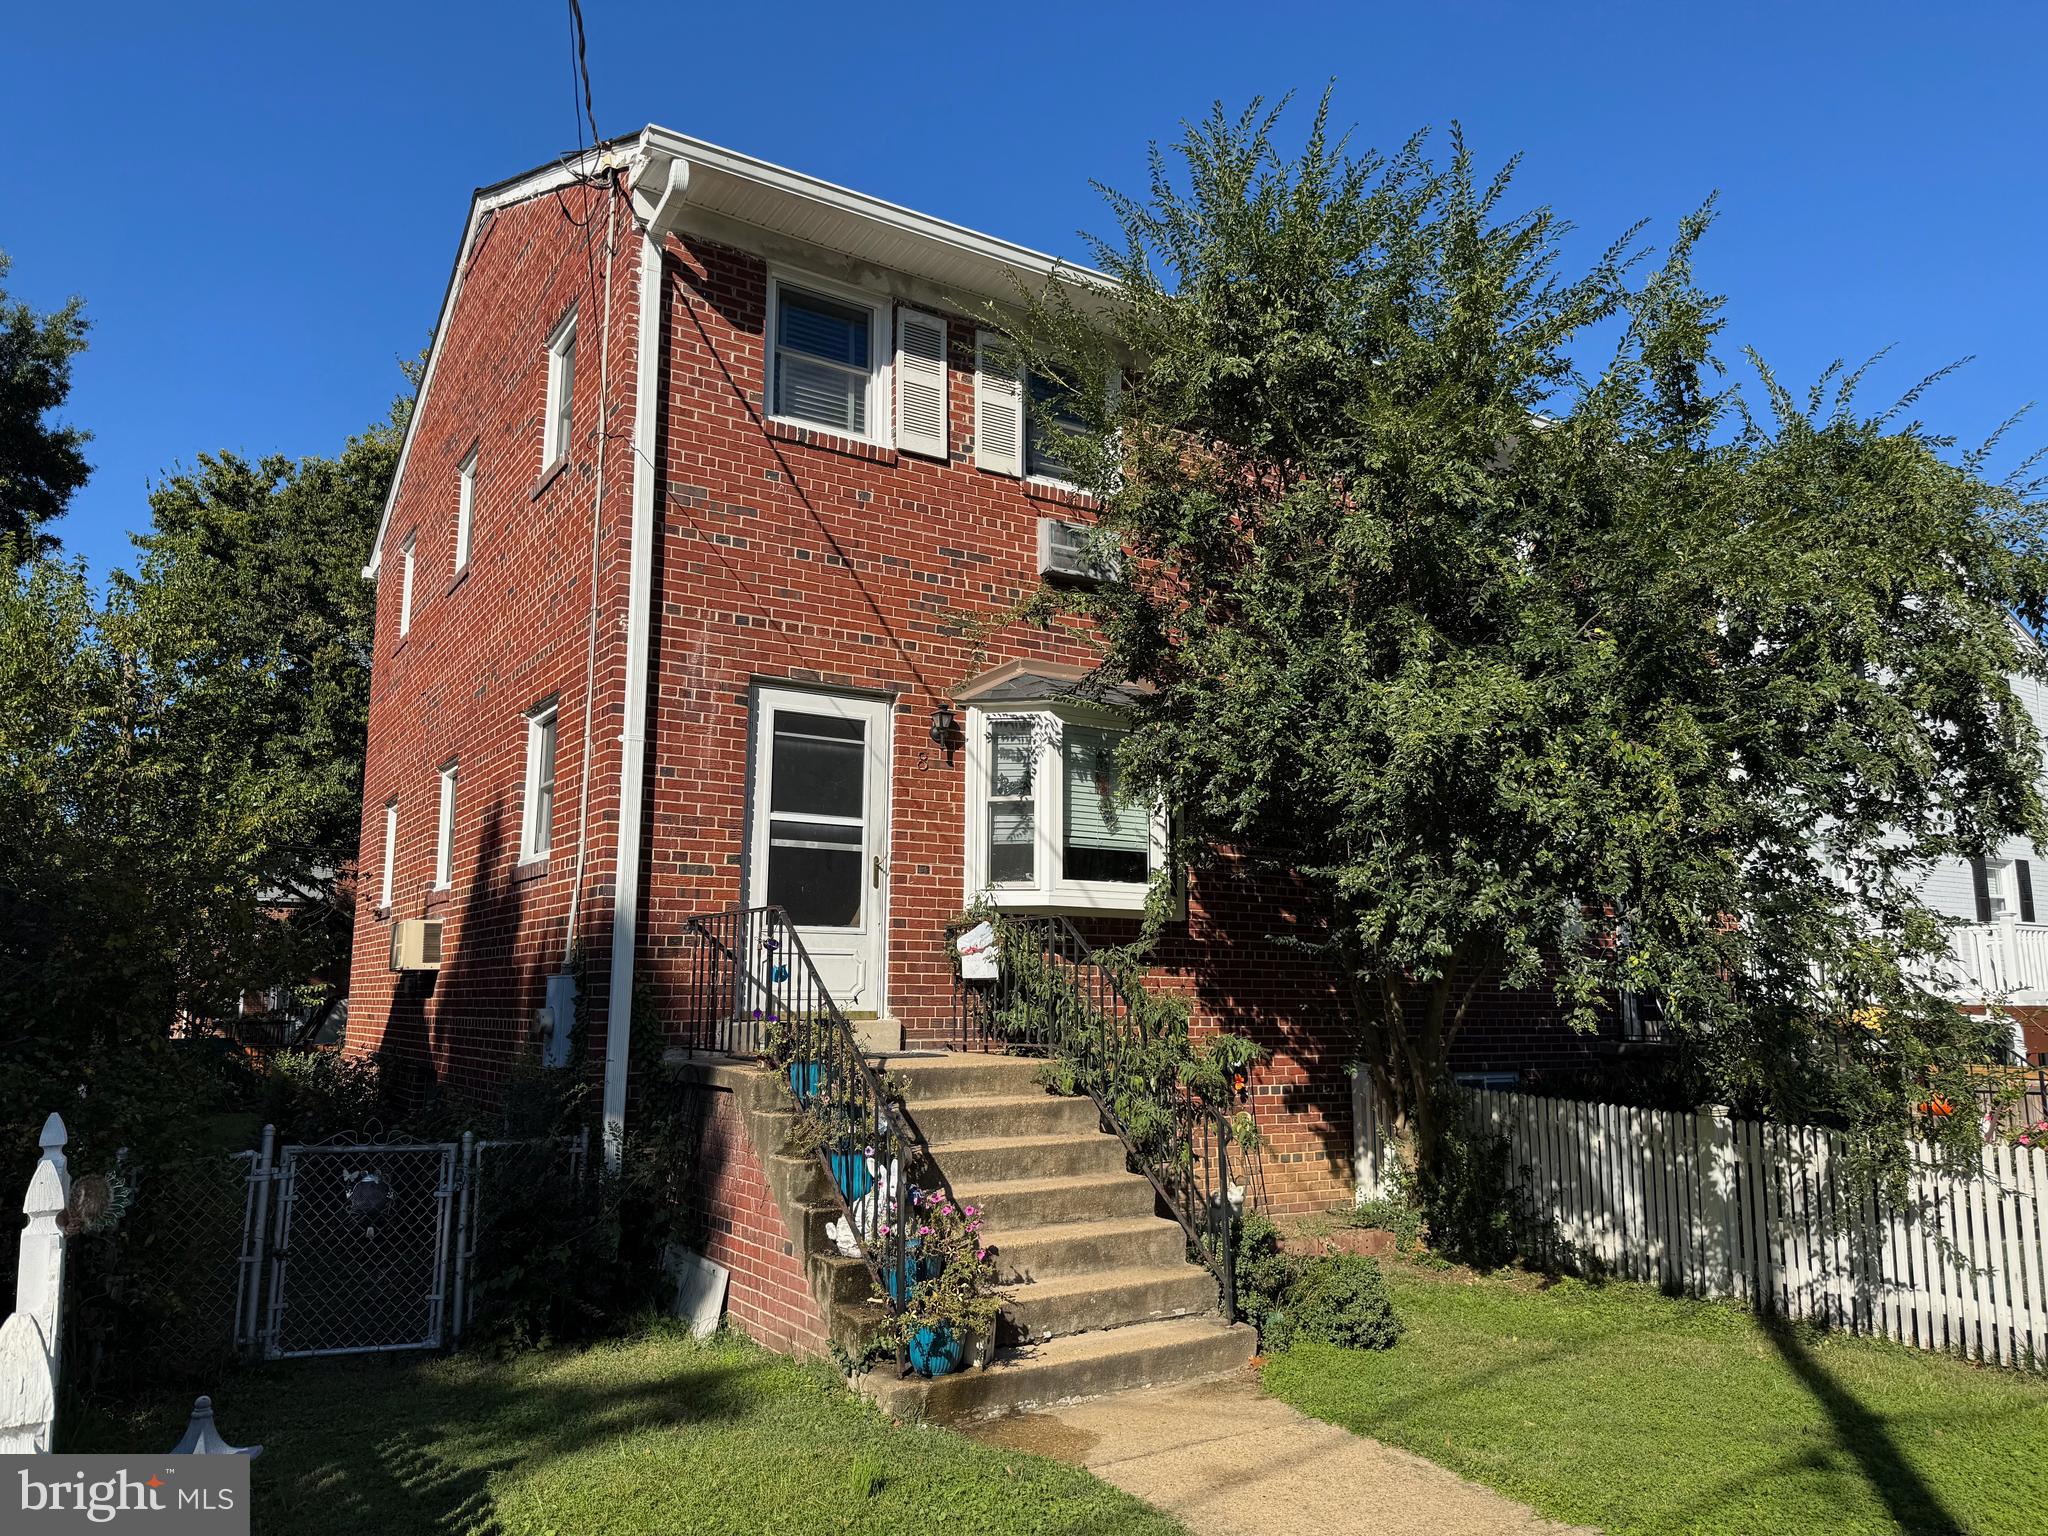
[948,918,1237,1321]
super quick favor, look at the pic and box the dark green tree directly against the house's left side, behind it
[119,412,401,1026]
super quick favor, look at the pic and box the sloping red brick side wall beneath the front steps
[678,1083,829,1356]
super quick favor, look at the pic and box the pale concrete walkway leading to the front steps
[961,1374,1597,1536]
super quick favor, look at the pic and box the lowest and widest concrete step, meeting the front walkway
[856,1317,1253,1423]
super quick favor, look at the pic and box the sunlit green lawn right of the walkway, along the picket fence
[1264,1262,2048,1536]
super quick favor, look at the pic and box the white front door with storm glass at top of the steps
[748,688,889,1012]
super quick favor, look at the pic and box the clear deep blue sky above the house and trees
[0,0,2048,573]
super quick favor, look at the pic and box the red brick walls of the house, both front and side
[348,177,1589,1210]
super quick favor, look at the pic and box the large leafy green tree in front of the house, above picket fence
[1016,100,2048,1176]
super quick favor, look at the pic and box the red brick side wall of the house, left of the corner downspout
[346,188,639,1096]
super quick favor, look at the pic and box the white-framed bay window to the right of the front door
[965,705,1165,911]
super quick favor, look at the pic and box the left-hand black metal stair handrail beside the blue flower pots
[684,907,958,1370]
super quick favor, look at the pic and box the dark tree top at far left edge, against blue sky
[0,250,92,567]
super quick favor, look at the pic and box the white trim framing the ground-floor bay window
[961,702,1167,913]
